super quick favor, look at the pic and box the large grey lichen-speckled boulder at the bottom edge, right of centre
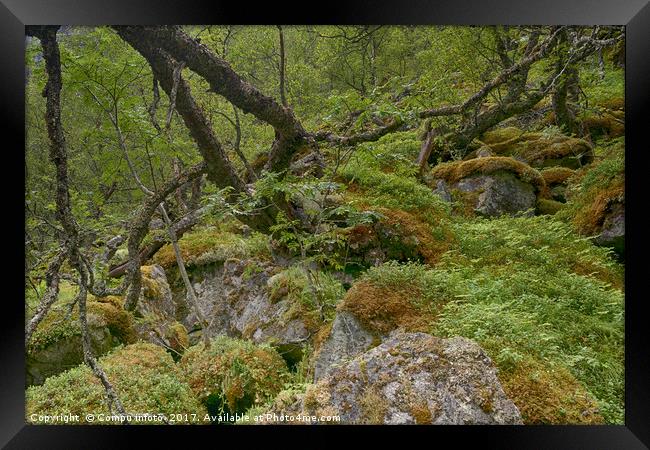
[265,332,522,425]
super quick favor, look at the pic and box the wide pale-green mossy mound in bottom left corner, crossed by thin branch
[26,343,206,424]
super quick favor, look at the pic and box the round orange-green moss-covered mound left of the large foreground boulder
[180,336,289,414]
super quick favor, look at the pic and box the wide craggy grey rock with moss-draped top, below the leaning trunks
[184,259,345,364]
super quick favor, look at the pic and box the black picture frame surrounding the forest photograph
[0,0,650,449]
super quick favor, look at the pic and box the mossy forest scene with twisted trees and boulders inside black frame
[25,25,625,425]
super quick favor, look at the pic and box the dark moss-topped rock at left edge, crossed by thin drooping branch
[26,297,136,386]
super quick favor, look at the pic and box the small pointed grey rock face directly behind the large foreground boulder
[314,311,373,381]
